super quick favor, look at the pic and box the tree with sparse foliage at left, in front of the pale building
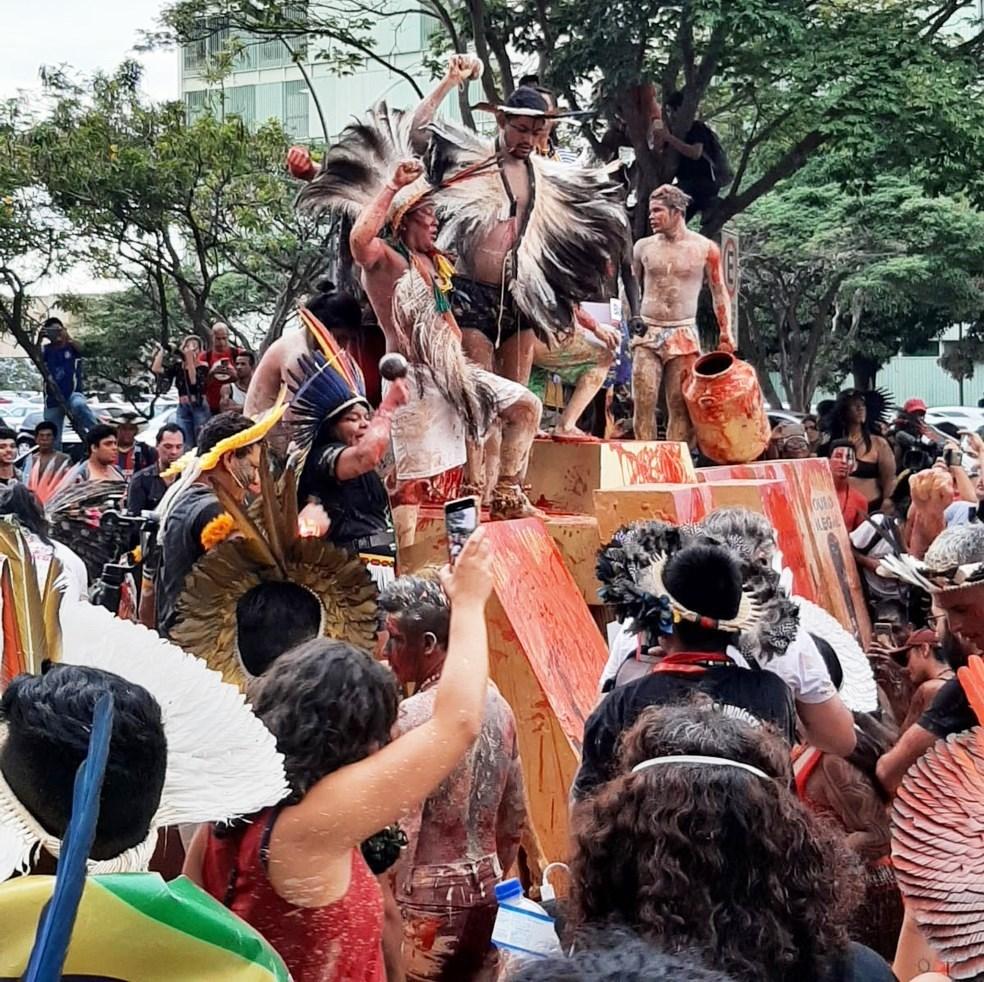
[28,63,332,354]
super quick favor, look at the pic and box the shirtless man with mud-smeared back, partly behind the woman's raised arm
[379,576,526,982]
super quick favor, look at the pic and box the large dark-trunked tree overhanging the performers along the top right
[150,0,984,236]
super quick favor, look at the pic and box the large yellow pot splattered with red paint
[683,351,772,464]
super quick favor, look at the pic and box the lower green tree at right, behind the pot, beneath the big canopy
[737,175,984,410]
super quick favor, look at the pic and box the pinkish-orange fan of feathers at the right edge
[892,656,984,979]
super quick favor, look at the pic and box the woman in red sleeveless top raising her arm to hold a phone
[184,531,492,982]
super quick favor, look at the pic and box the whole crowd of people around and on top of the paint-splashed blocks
[0,56,984,982]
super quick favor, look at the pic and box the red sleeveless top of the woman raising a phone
[202,808,386,982]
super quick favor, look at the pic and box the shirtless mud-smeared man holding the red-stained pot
[631,184,735,444]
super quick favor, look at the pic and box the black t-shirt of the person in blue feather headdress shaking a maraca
[297,443,389,547]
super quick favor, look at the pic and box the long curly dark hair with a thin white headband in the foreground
[571,707,860,982]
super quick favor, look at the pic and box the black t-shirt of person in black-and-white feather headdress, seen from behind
[572,665,796,799]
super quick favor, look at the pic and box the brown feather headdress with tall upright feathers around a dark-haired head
[170,450,376,689]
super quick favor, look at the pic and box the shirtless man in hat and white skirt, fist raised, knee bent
[349,160,541,518]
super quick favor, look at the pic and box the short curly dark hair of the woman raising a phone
[249,638,398,804]
